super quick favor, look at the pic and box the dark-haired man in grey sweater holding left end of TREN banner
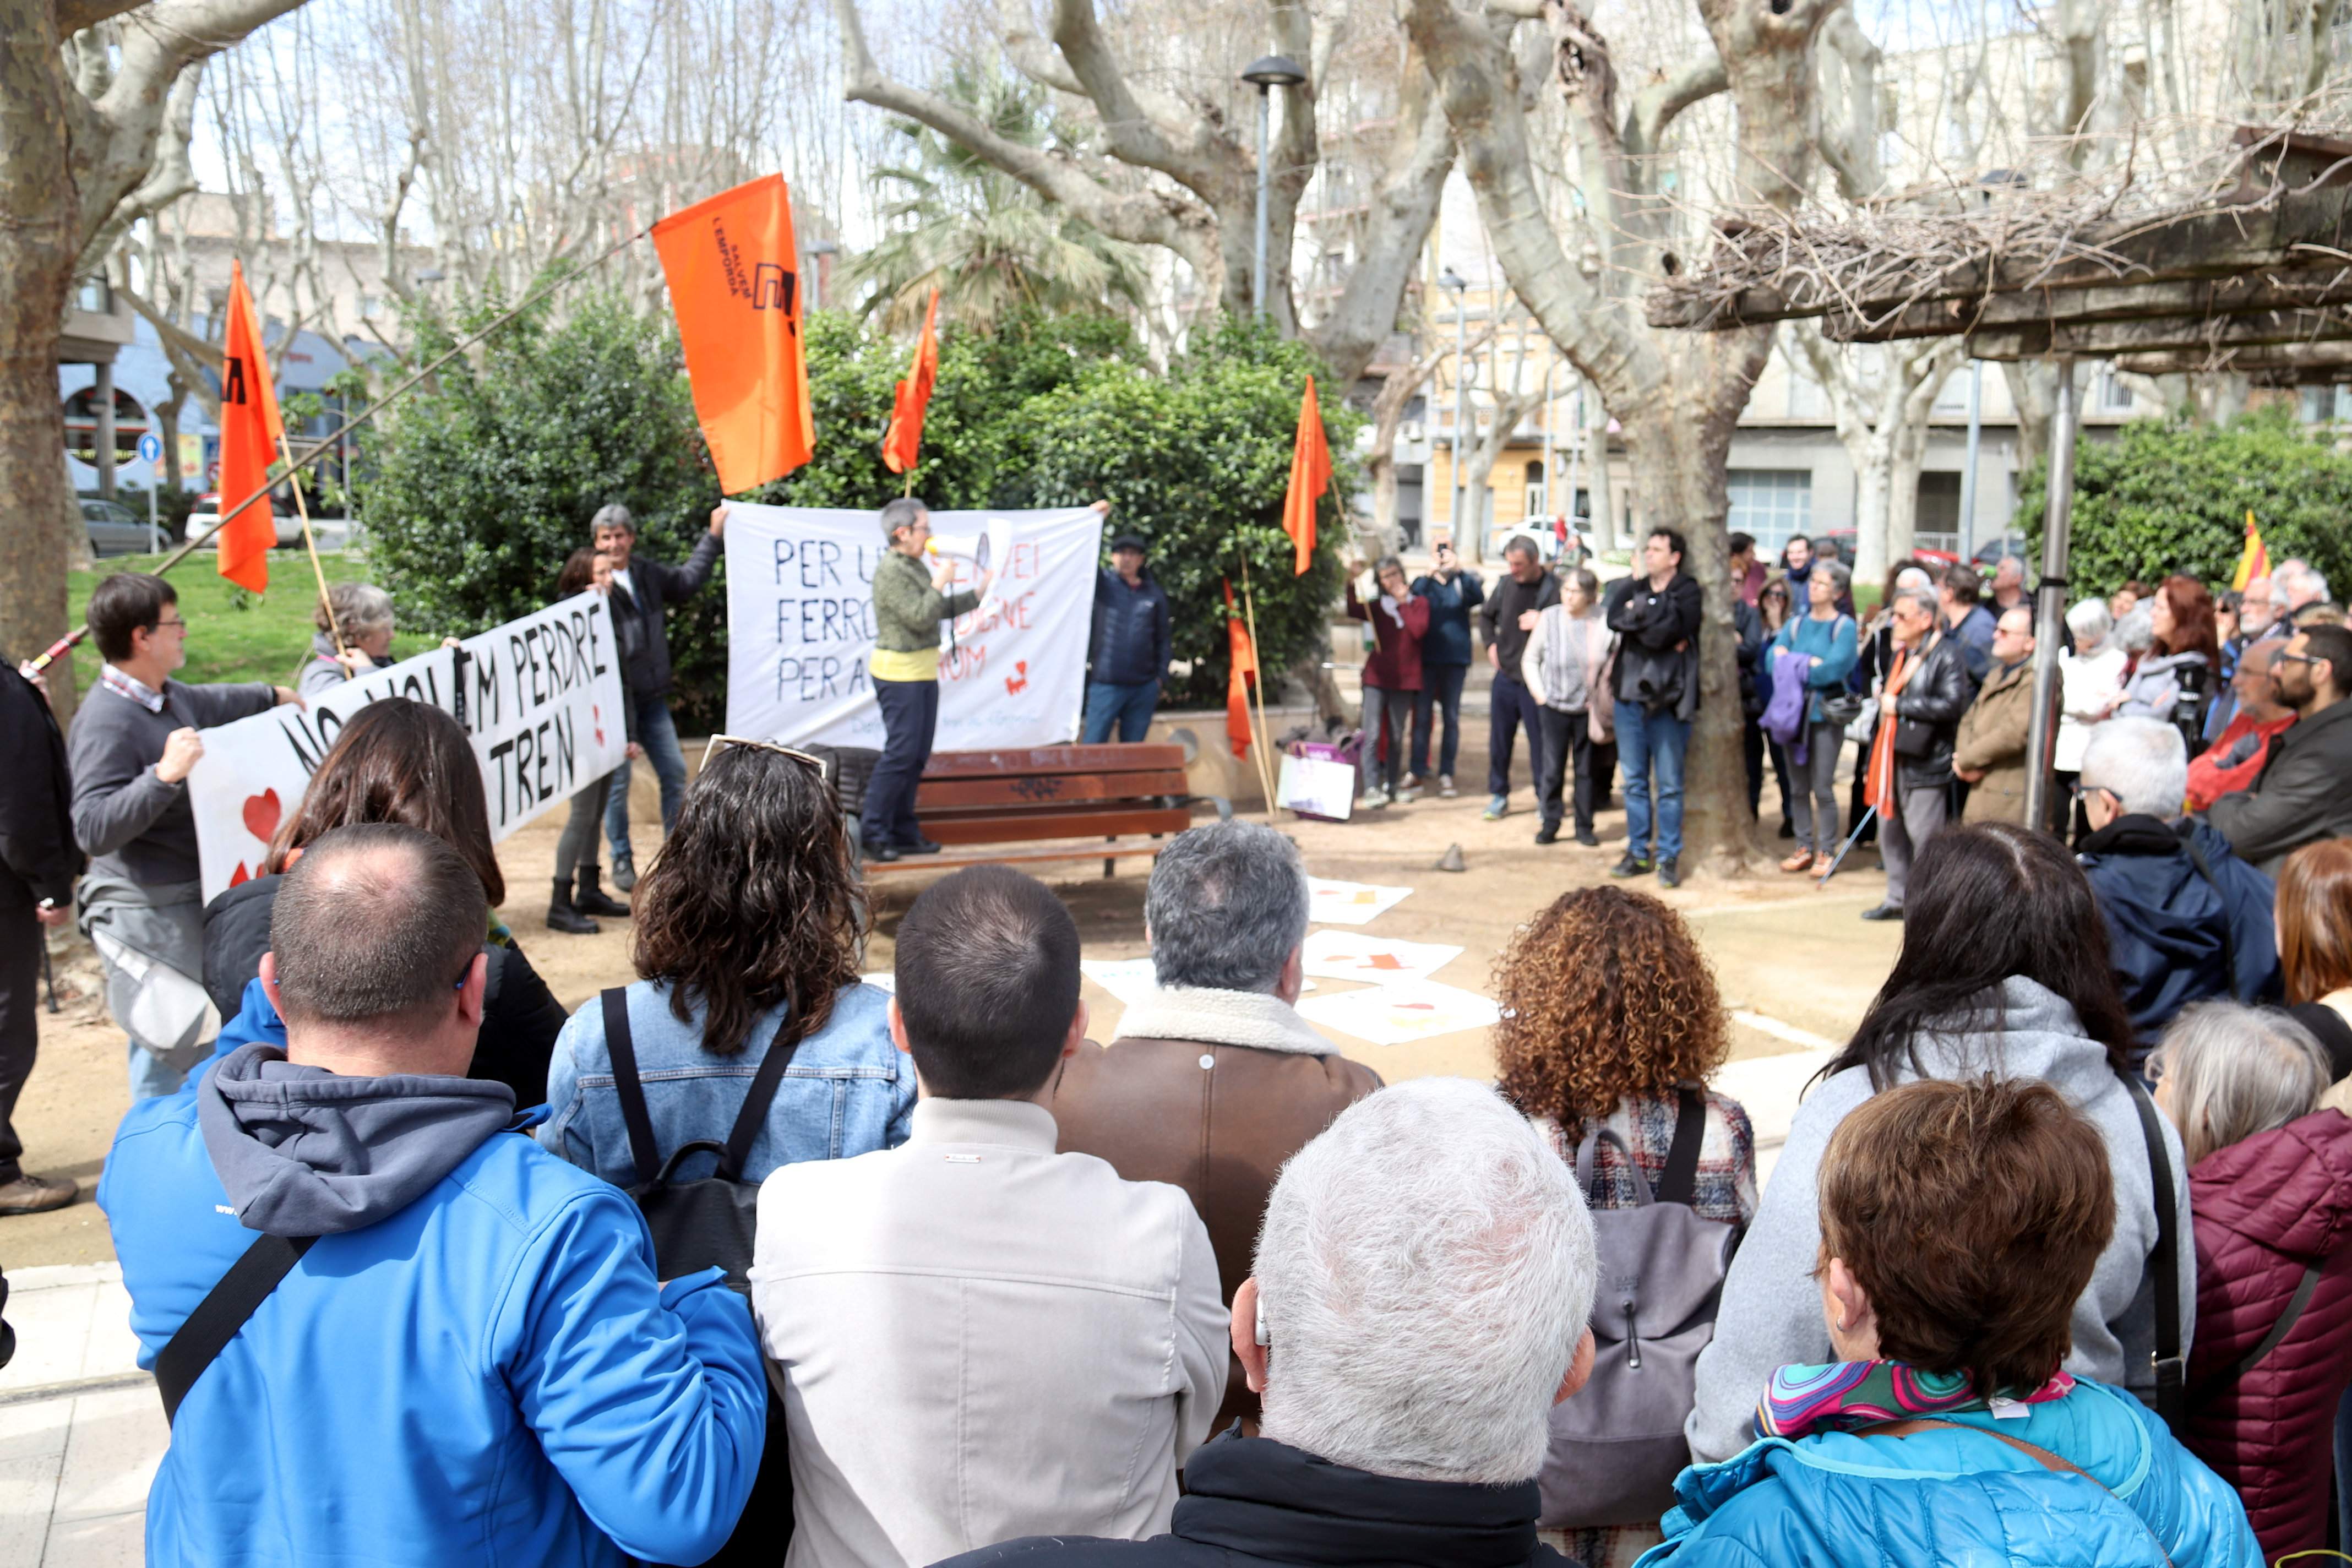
[68,571,301,1100]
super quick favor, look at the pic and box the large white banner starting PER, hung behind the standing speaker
[727,503,1103,752]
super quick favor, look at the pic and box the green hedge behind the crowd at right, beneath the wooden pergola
[2018,404,2352,600]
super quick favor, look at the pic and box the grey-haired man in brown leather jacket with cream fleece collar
[1049,820,1381,1429]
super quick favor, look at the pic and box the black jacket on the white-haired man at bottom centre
[939,1422,1574,1568]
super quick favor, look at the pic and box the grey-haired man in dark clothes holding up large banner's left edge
[588,500,727,889]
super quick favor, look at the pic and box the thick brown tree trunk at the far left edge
[0,0,301,703]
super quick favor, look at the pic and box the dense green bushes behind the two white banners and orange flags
[345,298,1362,731]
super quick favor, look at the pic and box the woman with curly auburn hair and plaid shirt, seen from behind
[1494,886,1757,1568]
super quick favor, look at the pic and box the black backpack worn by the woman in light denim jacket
[602,987,799,1568]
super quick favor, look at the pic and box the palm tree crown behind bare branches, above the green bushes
[847,63,1148,331]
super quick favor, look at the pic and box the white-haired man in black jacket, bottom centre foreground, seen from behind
[943,1079,1599,1568]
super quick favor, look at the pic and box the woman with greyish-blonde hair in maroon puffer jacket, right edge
[2147,1001,2352,1563]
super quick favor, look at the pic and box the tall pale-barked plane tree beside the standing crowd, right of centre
[1407,0,1839,874]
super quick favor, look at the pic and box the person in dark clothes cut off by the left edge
[0,670,83,1216]
